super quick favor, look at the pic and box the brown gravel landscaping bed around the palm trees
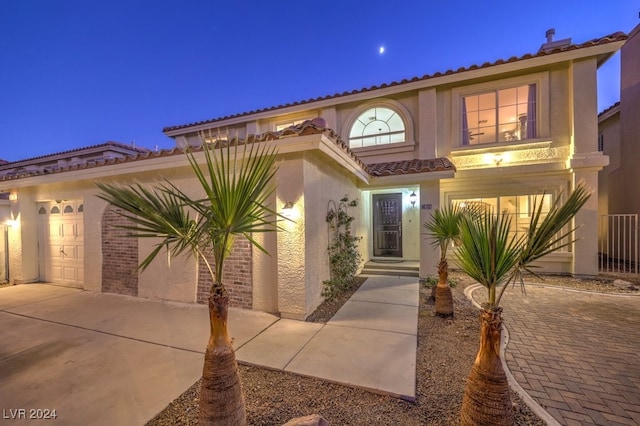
[147,273,640,426]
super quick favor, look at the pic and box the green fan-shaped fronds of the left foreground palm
[98,140,286,286]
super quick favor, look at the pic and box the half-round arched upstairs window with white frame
[349,106,406,148]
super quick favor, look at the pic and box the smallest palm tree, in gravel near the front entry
[423,204,462,317]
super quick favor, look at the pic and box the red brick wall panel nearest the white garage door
[102,206,138,296]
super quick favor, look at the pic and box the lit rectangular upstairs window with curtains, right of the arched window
[462,84,537,146]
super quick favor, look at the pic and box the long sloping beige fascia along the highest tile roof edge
[163,40,625,137]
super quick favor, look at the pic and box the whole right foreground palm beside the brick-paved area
[457,185,591,425]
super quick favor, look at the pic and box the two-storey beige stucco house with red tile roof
[0,28,627,318]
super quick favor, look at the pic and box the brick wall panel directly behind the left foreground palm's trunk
[196,237,253,309]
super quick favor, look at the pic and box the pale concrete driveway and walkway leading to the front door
[0,277,419,425]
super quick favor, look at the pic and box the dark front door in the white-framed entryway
[373,194,402,257]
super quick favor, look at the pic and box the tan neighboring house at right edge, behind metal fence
[598,25,640,266]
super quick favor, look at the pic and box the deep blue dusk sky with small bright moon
[0,0,640,161]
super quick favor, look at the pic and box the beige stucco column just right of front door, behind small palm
[420,180,440,277]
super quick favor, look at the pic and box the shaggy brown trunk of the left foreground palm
[198,285,246,426]
